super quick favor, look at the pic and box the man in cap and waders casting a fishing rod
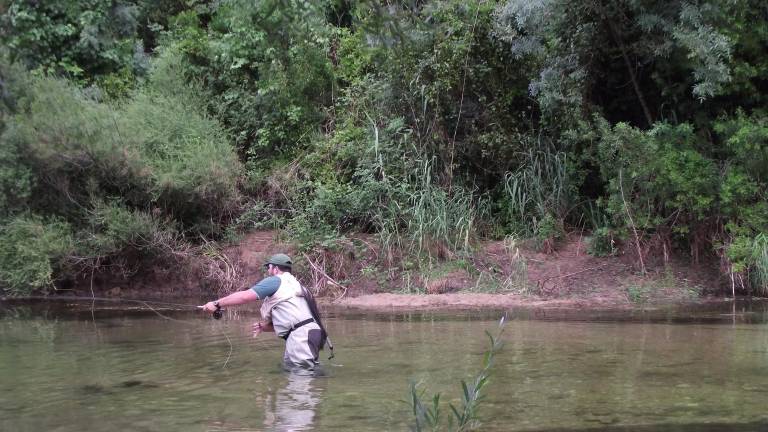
[199,254,333,370]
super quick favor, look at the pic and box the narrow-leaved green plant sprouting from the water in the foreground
[408,316,506,432]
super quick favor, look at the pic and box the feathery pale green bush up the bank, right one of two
[119,89,241,228]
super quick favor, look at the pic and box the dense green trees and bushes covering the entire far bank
[0,0,768,293]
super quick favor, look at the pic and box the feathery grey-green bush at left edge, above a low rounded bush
[0,78,143,213]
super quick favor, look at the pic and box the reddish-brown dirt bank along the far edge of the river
[75,231,721,311]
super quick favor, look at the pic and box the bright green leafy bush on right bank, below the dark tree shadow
[598,122,720,234]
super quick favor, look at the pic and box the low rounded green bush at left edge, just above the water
[0,214,75,295]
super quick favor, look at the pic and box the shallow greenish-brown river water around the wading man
[0,302,768,432]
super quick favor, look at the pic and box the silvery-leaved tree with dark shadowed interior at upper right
[497,0,735,127]
